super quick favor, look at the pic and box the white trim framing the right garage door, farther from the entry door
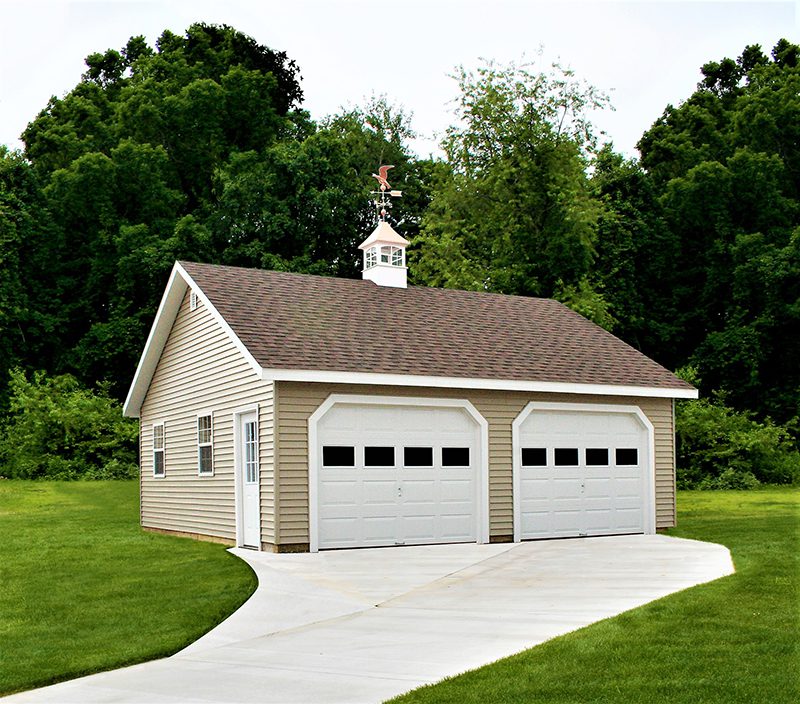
[511,401,656,543]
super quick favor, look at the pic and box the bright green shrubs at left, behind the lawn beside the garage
[0,370,139,479]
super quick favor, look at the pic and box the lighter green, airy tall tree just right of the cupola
[412,63,606,320]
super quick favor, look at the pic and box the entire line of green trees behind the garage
[0,24,800,484]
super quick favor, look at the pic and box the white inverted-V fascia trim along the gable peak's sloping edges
[122,262,262,418]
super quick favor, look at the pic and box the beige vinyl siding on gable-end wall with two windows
[140,291,275,543]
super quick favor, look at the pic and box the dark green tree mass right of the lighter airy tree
[592,40,800,423]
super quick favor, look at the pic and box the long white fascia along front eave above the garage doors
[261,369,698,398]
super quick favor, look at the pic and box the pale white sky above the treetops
[0,0,800,156]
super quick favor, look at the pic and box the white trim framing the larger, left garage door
[308,394,489,552]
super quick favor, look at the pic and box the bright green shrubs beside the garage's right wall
[675,398,800,489]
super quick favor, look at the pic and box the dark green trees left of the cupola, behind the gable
[9,24,425,398]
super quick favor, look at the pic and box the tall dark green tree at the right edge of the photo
[639,40,800,422]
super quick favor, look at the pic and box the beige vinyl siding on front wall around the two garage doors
[275,382,675,545]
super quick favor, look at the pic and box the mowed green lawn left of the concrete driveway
[0,480,256,694]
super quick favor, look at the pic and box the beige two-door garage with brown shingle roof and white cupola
[125,222,697,551]
